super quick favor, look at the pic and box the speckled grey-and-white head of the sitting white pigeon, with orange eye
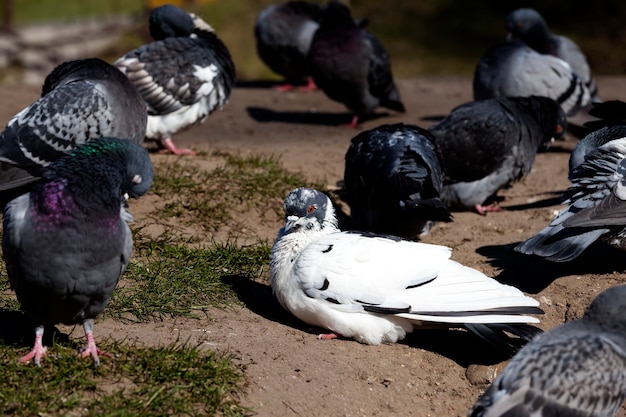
[283,188,337,233]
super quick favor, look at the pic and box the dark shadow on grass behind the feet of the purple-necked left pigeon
[0,309,78,348]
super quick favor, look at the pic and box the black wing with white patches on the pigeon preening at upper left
[115,37,234,114]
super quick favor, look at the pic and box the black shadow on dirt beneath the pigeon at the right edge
[476,242,626,294]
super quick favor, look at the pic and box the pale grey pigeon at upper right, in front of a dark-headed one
[473,40,591,116]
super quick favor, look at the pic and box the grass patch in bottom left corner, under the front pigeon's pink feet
[0,343,249,416]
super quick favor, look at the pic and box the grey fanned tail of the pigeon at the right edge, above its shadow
[515,223,609,262]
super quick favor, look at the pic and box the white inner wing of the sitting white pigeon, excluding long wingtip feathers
[294,232,450,313]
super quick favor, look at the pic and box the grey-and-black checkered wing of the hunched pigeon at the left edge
[0,81,114,176]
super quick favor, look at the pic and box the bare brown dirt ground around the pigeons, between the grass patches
[0,77,626,417]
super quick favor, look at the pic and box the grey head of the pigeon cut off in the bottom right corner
[585,285,626,339]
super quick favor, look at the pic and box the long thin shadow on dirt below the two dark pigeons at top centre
[246,107,389,126]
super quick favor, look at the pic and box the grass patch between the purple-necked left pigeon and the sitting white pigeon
[106,234,270,321]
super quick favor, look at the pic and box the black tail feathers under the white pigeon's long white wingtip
[465,323,543,355]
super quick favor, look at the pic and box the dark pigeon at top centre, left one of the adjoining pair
[254,1,322,91]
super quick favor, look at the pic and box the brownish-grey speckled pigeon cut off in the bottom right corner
[468,285,626,417]
